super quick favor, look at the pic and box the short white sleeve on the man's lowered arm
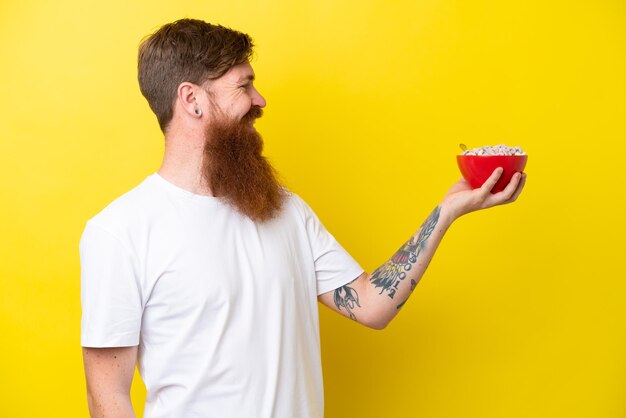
[79,221,143,347]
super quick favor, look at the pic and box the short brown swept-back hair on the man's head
[137,19,254,133]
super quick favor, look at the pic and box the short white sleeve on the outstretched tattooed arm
[295,195,364,295]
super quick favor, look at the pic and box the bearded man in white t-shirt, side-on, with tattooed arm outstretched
[80,19,525,418]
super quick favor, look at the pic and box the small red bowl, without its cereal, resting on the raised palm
[456,155,528,193]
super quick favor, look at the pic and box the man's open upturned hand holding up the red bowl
[441,167,526,219]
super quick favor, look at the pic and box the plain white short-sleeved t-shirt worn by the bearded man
[80,173,363,418]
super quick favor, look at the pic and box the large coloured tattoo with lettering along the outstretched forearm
[370,206,441,298]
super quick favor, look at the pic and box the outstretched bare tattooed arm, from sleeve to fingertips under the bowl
[319,169,526,329]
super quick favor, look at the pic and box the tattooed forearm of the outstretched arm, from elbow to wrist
[358,205,455,329]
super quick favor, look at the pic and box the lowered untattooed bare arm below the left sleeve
[83,346,137,418]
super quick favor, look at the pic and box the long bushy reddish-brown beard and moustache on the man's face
[202,106,286,222]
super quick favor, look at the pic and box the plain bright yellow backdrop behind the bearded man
[0,0,626,418]
